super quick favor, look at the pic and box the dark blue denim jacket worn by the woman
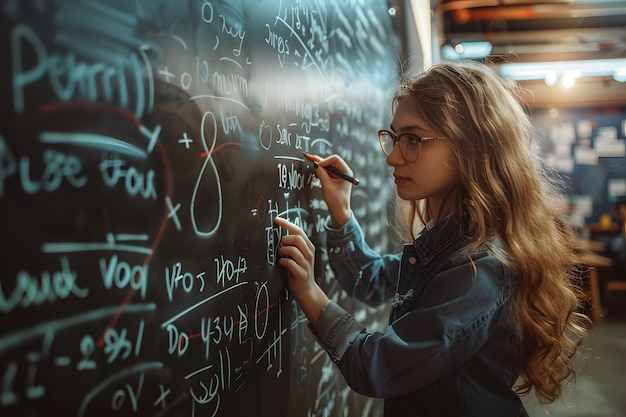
[312,215,527,417]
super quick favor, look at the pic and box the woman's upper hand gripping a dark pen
[313,155,352,229]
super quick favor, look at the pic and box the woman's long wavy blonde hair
[394,62,589,404]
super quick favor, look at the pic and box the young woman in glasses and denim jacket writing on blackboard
[276,62,588,417]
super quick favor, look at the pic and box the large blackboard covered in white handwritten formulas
[0,0,401,417]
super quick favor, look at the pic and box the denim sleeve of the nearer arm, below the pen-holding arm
[316,257,510,398]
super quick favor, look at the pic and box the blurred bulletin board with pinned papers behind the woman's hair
[532,107,626,223]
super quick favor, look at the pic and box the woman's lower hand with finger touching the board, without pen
[274,217,328,325]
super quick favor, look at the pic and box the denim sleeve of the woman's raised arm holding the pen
[326,214,401,307]
